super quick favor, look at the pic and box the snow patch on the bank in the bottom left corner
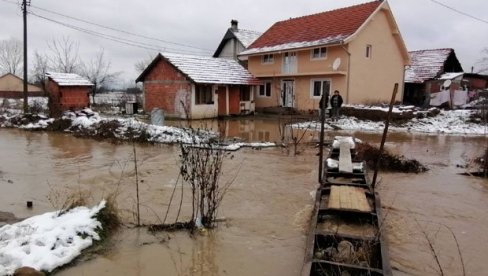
[0,201,105,275]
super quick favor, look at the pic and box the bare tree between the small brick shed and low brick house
[81,48,120,103]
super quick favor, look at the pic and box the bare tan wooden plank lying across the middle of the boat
[327,185,372,213]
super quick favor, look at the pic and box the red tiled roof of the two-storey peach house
[241,1,384,55]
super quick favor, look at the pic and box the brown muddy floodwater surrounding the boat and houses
[0,121,488,275]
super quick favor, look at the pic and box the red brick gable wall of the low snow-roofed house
[144,59,191,115]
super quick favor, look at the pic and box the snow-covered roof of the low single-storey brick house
[136,53,260,85]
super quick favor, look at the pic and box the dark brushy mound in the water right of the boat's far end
[356,143,429,173]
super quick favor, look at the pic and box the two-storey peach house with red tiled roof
[239,1,409,111]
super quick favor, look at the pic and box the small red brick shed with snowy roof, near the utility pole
[46,72,93,117]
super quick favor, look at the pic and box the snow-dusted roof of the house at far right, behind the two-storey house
[405,48,462,83]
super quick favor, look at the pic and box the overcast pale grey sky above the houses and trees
[0,0,488,87]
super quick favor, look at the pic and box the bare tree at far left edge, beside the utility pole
[0,38,24,75]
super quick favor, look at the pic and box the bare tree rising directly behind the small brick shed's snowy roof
[47,37,80,73]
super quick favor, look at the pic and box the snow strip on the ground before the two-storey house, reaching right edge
[294,110,488,135]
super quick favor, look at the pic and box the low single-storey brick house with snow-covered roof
[136,53,260,119]
